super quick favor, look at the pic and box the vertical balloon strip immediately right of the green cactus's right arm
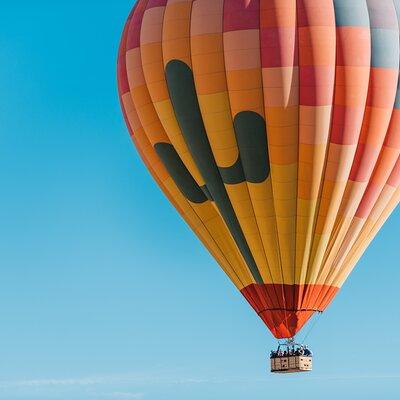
[260,0,299,290]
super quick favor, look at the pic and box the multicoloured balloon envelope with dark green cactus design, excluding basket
[118,0,400,372]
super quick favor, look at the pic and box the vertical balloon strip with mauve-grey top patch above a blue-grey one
[319,0,399,288]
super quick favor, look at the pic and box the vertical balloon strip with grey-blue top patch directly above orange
[303,0,371,303]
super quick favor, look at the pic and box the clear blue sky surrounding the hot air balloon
[0,0,400,400]
